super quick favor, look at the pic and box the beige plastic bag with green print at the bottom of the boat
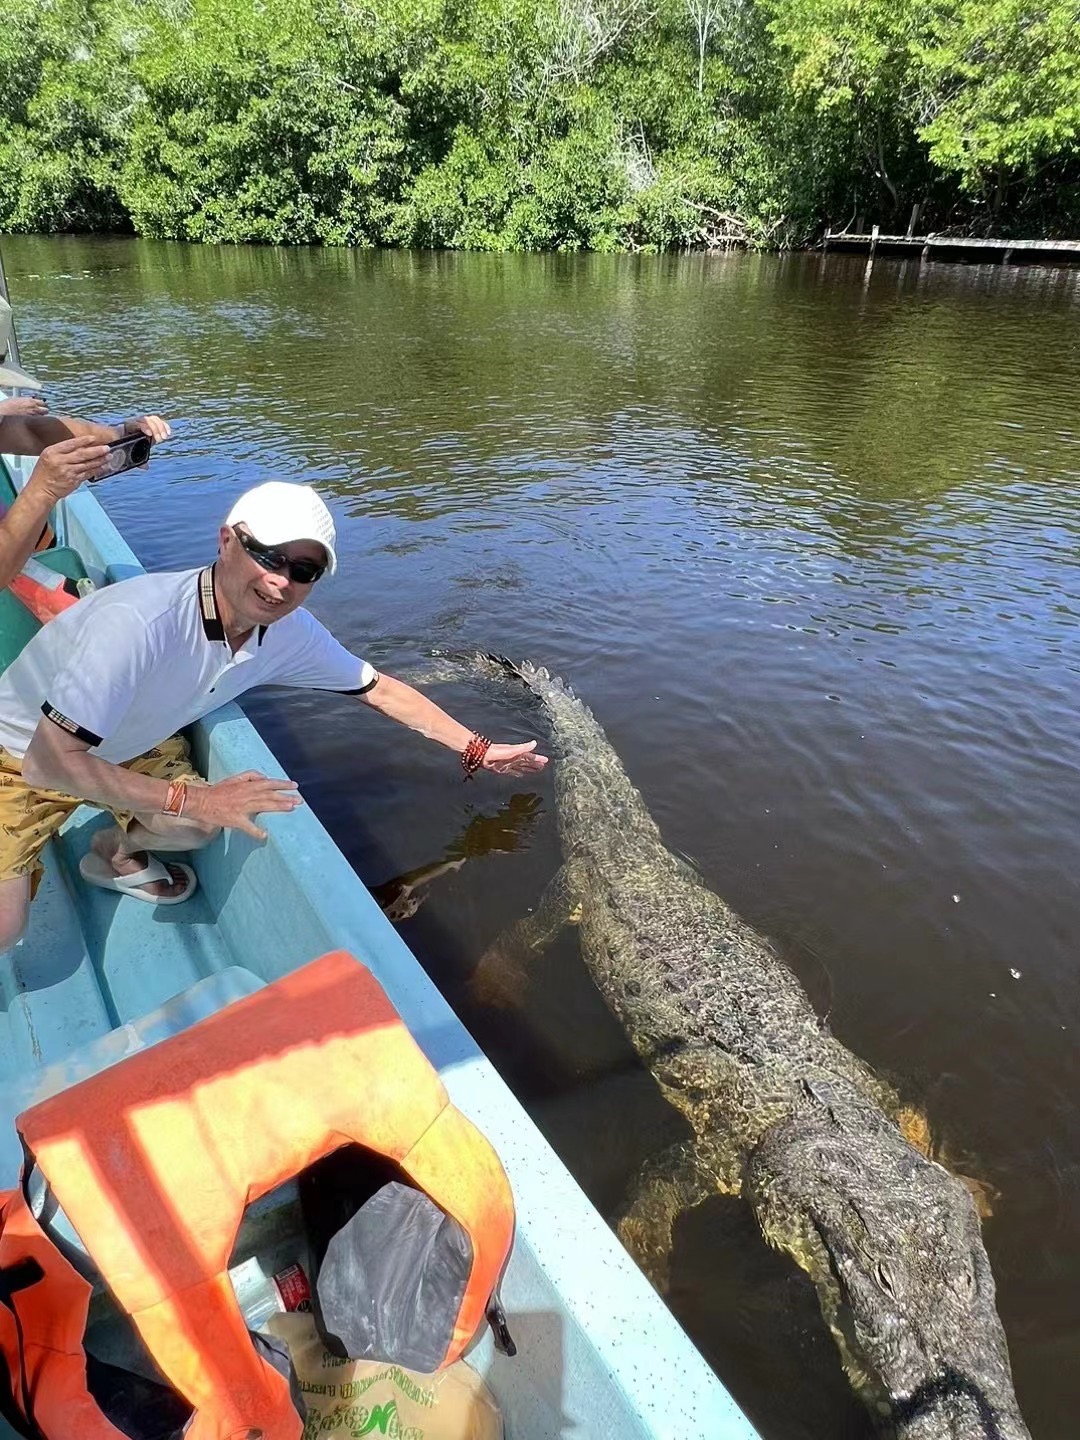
[265,1313,503,1440]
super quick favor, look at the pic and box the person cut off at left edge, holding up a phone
[0,295,171,589]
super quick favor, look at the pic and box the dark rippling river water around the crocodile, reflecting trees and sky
[4,239,1080,1440]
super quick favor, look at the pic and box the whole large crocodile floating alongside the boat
[444,655,1030,1440]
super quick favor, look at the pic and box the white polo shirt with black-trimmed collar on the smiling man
[0,567,379,765]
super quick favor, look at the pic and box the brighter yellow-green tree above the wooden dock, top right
[769,0,1080,230]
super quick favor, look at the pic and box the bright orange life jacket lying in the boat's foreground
[0,950,513,1440]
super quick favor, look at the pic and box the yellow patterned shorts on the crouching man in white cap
[0,734,203,896]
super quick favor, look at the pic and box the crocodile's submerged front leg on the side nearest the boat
[616,1139,742,1295]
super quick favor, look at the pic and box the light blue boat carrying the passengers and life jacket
[0,318,756,1440]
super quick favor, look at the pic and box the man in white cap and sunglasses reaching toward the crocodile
[0,481,547,952]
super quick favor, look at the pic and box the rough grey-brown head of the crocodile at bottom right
[747,1080,1030,1440]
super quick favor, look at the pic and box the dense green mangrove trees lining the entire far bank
[0,0,1080,251]
